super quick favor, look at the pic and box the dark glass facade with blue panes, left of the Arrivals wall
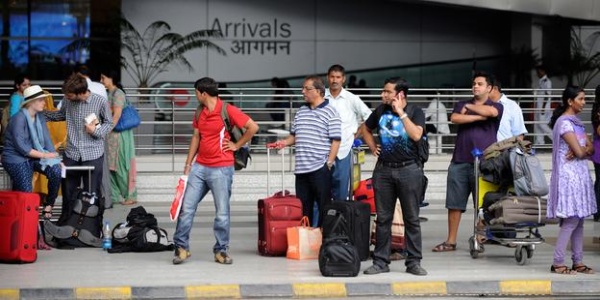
[0,0,120,80]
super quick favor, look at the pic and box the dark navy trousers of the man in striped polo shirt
[296,164,331,227]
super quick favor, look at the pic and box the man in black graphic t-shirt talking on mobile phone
[362,78,427,276]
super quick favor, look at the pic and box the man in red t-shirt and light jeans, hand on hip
[173,77,258,264]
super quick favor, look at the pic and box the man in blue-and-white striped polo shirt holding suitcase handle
[269,75,342,226]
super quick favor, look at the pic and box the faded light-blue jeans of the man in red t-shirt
[173,163,233,253]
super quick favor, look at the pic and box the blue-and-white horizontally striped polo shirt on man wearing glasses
[290,99,342,174]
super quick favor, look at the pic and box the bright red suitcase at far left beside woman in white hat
[0,191,40,263]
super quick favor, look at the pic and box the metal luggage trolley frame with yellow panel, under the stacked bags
[469,149,544,265]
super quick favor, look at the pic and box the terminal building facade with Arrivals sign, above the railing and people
[0,0,600,88]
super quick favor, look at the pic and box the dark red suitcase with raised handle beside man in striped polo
[258,150,302,256]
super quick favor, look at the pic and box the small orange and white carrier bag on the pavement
[286,216,323,259]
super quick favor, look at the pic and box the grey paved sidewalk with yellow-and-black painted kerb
[0,201,600,299]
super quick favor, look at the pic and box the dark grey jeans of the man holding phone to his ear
[373,163,423,267]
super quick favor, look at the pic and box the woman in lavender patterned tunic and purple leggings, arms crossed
[547,86,597,274]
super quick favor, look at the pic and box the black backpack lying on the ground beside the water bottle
[108,206,175,253]
